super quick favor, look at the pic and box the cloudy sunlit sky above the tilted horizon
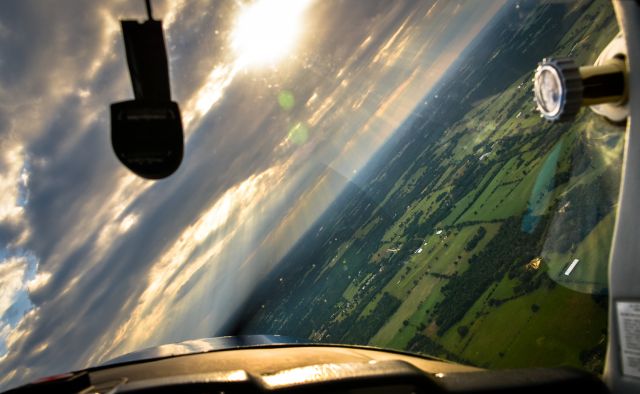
[0,0,503,388]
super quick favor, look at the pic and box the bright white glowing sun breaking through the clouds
[231,0,310,67]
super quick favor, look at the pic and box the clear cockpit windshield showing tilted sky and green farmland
[0,0,624,388]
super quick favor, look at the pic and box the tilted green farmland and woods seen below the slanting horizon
[241,1,623,372]
